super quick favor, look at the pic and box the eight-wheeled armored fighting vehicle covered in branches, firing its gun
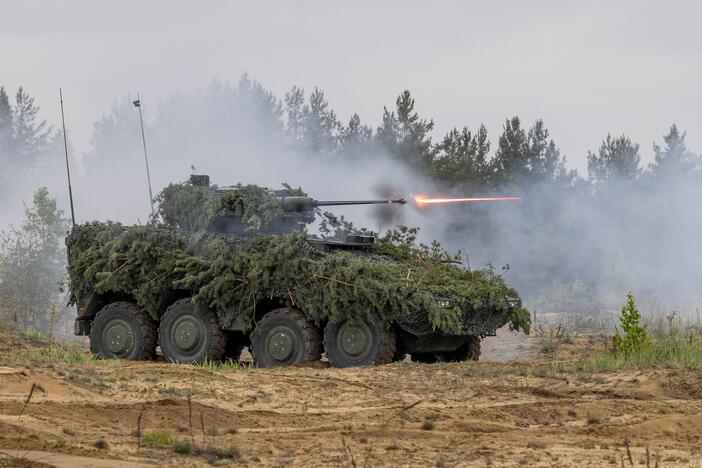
[66,176,529,367]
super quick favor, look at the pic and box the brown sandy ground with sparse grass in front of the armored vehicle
[0,333,702,467]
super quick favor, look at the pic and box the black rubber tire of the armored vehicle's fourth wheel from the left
[324,314,397,367]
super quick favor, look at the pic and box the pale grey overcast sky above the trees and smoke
[0,0,702,171]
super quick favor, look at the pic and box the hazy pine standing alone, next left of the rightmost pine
[587,135,641,189]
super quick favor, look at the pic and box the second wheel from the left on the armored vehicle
[158,299,227,363]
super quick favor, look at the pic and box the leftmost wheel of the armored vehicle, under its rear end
[90,302,156,360]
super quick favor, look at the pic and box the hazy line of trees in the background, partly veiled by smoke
[0,76,702,326]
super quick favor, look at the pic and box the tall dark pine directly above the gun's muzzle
[376,91,436,173]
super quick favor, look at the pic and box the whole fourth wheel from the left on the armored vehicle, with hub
[324,314,396,367]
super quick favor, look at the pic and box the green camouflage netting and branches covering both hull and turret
[67,179,529,335]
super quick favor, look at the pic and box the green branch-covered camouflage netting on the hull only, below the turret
[68,223,529,334]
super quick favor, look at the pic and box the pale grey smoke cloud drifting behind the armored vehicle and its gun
[0,79,702,326]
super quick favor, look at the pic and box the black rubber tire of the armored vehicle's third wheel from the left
[250,308,322,368]
